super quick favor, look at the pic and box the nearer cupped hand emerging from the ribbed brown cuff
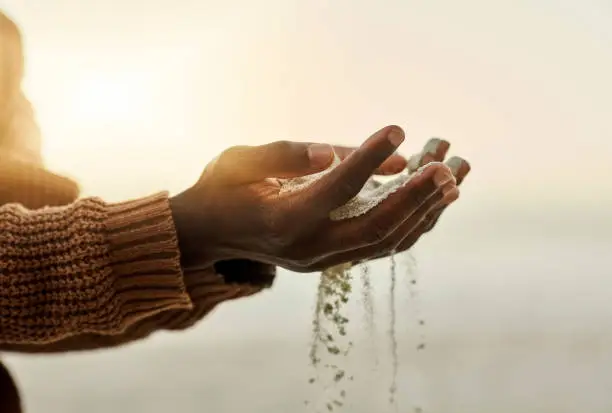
[171,126,459,272]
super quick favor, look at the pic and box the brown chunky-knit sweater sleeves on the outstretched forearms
[0,193,273,346]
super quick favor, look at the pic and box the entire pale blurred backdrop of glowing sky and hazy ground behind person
[0,0,612,413]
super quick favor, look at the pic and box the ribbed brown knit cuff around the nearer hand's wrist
[105,192,193,326]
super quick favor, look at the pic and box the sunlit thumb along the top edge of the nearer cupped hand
[214,141,335,183]
